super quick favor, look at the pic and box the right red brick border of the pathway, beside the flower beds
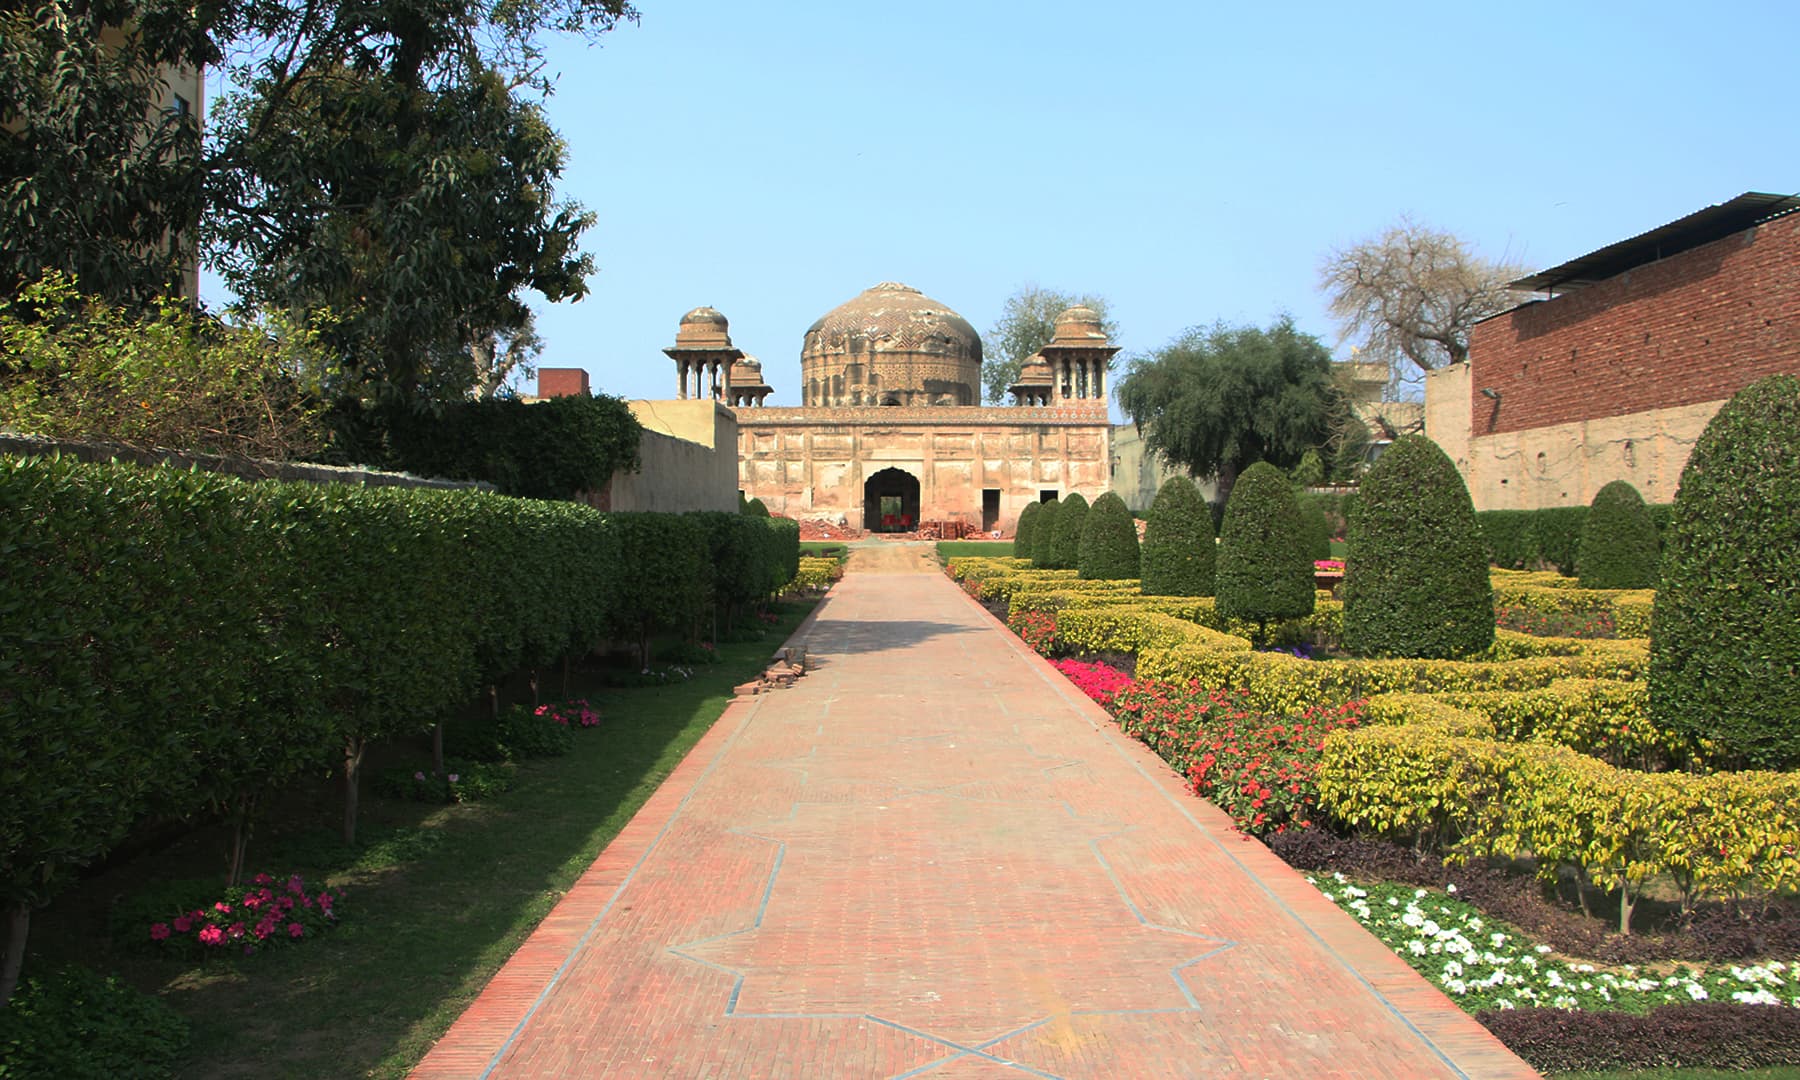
[965,579,1539,1078]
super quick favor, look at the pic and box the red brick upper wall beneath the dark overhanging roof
[1469,214,1800,437]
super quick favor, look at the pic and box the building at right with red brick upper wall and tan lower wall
[1426,193,1800,509]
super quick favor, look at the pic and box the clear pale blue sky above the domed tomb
[214,0,1800,405]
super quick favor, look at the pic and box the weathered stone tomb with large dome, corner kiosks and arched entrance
[670,283,1118,533]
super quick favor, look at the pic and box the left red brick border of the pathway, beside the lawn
[410,592,832,1080]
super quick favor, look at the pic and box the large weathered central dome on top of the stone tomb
[799,281,981,407]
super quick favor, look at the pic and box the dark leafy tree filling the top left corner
[0,0,214,306]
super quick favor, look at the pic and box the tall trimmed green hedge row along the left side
[0,457,799,909]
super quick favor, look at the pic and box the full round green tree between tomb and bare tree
[1118,315,1339,502]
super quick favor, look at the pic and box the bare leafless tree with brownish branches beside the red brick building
[1319,218,1525,392]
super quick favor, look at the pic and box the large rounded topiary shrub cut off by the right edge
[1649,374,1800,769]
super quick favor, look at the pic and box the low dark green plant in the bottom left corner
[0,964,187,1080]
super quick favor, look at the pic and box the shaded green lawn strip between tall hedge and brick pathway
[27,601,814,1078]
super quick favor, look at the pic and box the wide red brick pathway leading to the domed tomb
[414,547,1534,1080]
